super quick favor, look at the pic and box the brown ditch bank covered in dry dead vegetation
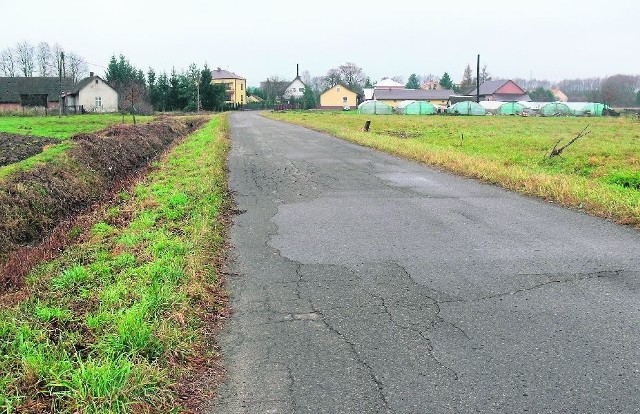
[0,118,205,286]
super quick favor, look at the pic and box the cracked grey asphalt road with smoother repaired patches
[209,112,640,413]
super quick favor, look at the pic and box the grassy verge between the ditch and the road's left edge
[0,116,229,413]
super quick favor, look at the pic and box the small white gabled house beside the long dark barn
[65,72,118,113]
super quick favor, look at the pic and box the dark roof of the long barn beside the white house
[0,76,73,103]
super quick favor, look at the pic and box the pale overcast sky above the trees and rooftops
[5,0,640,86]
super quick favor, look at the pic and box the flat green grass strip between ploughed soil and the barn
[0,114,153,140]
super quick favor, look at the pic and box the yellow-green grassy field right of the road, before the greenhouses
[265,112,640,226]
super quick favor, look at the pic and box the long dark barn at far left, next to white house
[0,76,74,112]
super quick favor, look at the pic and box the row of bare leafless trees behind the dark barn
[0,41,88,82]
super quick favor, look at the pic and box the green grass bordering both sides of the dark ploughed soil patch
[0,114,154,179]
